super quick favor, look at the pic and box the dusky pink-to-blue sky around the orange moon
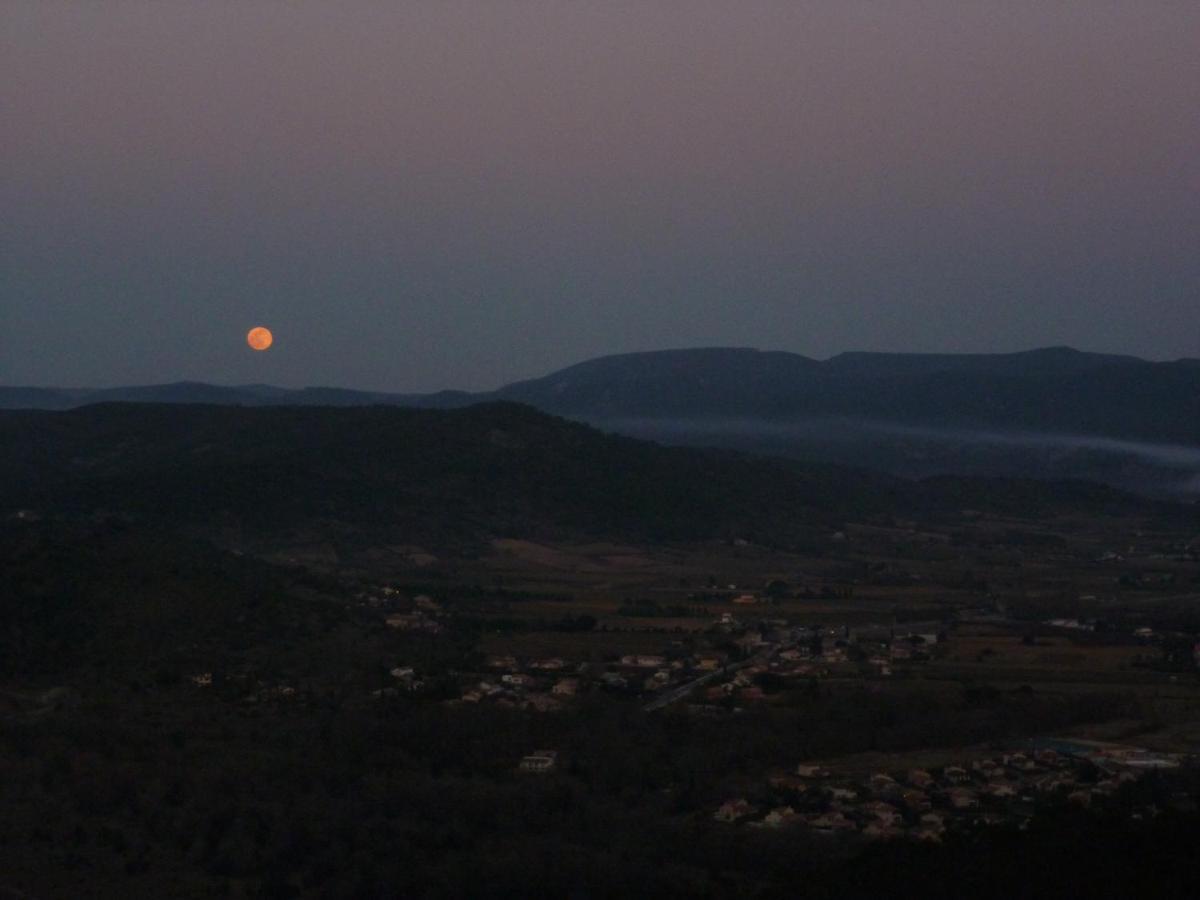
[0,0,1200,390]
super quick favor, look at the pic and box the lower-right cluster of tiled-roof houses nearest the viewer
[713,748,1180,841]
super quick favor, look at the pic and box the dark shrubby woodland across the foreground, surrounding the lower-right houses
[0,686,1200,898]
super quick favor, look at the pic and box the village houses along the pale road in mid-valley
[368,588,1200,714]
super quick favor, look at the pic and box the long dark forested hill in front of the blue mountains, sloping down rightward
[0,403,1139,544]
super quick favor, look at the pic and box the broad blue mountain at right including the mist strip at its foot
[489,347,1200,499]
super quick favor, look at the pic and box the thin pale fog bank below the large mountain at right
[588,418,1200,499]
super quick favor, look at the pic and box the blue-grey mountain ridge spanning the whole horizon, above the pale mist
[7,347,1200,445]
